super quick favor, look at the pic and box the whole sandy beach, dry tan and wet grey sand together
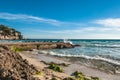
[20,51,120,80]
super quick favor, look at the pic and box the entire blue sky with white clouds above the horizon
[0,0,120,39]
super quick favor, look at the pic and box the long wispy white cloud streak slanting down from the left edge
[0,13,82,26]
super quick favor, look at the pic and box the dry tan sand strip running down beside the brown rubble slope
[20,51,69,80]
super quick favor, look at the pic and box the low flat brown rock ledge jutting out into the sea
[1,42,75,50]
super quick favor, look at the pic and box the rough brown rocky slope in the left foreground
[0,46,37,80]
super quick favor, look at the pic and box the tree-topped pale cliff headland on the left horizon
[0,25,23,39]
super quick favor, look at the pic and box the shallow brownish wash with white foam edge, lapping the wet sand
[36,50,120,75]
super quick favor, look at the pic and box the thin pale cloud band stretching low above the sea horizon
[30,27,113,35]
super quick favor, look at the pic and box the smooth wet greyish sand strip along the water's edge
[20,51,120,80]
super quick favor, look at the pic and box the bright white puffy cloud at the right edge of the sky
[94,18,120,27]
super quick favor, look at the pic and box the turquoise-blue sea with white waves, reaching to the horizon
[0,39,120,65]
